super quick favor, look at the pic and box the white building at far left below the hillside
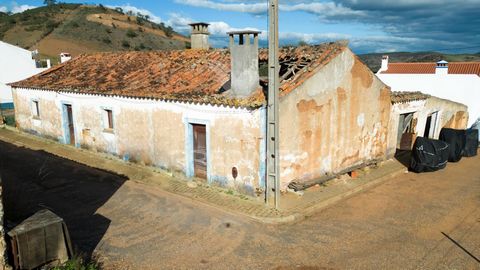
[0,41,50,108]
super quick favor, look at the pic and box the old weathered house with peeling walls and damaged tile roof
[12,31,391,198]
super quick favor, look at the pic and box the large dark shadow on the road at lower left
[0,142,127,259]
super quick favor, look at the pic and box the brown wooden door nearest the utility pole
[193,125,207,179]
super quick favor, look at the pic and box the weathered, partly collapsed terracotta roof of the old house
[11,43,346,107]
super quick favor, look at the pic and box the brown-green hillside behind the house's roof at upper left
[0,4,189,62]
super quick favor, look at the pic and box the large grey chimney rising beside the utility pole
[227,31,260,97]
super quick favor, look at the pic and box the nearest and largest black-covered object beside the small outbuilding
[410,137,449,172]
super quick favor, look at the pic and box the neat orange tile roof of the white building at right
[381,62,480,76]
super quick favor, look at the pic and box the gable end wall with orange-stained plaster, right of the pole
[280,49,391,188]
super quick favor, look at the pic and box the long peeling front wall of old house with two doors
[13,88,265,194]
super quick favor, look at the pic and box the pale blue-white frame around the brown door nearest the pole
[184,118,212,184]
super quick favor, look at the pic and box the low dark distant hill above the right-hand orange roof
[359,52,480,72]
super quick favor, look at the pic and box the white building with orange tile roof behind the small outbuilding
[377,56,480,126]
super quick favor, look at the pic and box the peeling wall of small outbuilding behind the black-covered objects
[388,97,468,154]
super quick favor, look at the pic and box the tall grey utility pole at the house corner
[266,0,280,209]
